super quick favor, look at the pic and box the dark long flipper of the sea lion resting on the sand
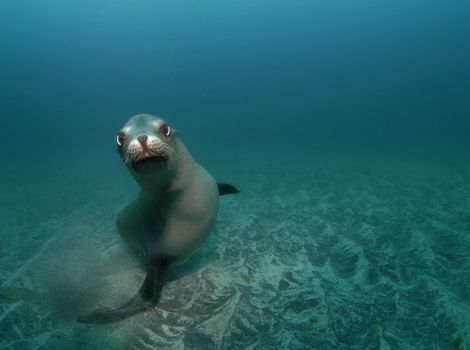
[77,258,171,324]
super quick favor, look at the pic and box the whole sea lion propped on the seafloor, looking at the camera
[78,114,239,323]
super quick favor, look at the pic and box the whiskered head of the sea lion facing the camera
[116,114,176,174]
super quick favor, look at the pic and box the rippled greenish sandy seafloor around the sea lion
[0,152,470,350]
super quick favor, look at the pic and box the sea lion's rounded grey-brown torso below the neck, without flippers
[117,146,219,258]
